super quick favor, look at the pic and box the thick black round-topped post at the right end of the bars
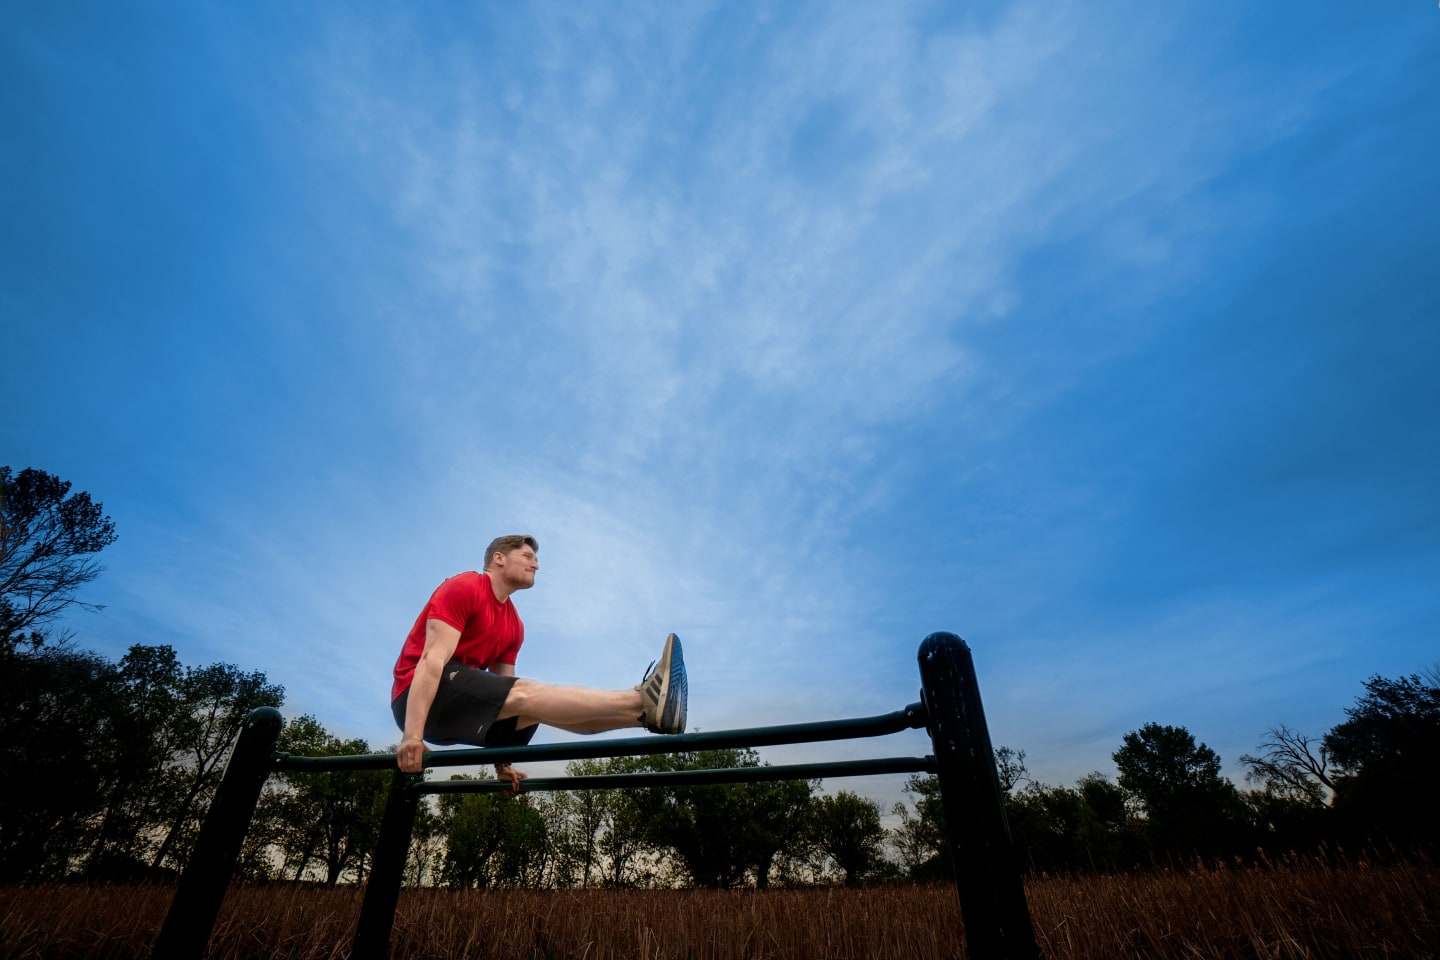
[920,633,1040,960]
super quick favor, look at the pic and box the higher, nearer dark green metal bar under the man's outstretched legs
[271,704,924,770]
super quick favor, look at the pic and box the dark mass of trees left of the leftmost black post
[0,643,282,882]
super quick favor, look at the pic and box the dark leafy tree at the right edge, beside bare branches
[1323,668,1440,843]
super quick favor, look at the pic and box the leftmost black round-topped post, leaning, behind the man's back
[150,707,285,960]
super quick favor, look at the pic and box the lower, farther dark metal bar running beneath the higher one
[420,757,936,794]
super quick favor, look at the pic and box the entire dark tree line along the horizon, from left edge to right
[0,468,1440,888]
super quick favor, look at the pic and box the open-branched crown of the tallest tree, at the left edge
[0,466,115,653]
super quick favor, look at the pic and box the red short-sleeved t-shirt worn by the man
[390,570,526,699]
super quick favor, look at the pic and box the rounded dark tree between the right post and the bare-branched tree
[1112,723,1244,853]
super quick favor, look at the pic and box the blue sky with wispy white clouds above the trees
[0,3,1440,802]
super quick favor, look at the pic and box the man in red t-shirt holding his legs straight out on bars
[390,534,688,792]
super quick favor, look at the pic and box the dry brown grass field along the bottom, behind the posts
[0,861,1440,960]
